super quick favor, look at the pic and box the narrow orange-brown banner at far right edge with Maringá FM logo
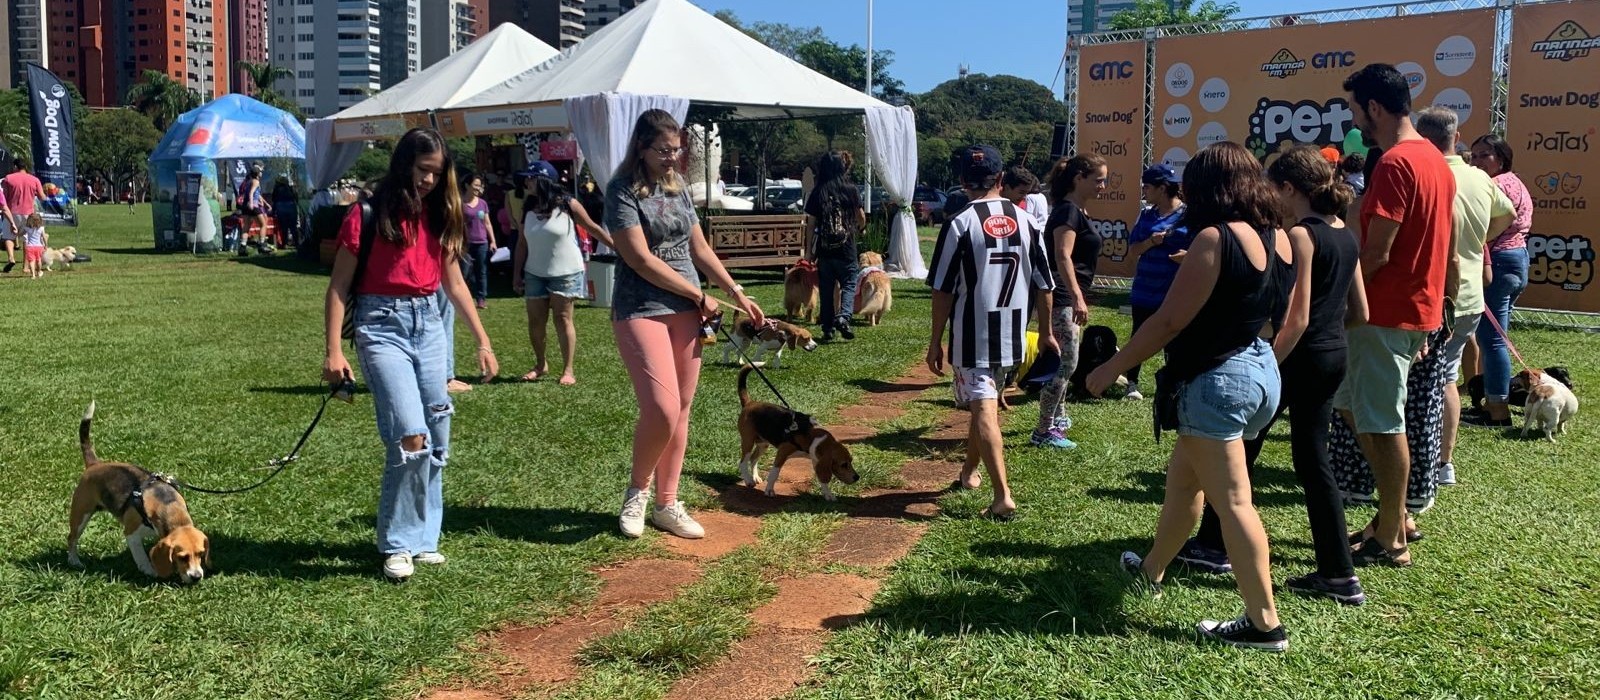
[1506,2,1600,312]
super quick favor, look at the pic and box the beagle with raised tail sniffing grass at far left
[67,401,211,583]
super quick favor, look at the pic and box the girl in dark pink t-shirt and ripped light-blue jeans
[322,129,499,582]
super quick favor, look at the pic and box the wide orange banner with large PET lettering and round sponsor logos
[1152,10,1496,176]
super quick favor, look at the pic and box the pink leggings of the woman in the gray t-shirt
[611,312,701,505]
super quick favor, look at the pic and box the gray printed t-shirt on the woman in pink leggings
[605,174,699,321]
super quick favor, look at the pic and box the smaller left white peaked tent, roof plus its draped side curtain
[306,22,558,189]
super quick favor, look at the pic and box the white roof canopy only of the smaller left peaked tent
[331,22,558,141]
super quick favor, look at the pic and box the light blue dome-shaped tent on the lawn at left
[150,94,310,253]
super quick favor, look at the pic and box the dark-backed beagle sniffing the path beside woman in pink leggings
[739,368,861,500]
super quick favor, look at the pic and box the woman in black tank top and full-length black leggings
[1178,145,1366,606]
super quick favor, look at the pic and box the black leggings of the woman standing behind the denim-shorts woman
[1195,348,1355,579]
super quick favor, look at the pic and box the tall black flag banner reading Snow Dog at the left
[27,64,78,225]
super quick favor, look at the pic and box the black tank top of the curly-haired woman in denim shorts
[1166,225,1294,380]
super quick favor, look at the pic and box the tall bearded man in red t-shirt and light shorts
[1333,64,1458,566]
